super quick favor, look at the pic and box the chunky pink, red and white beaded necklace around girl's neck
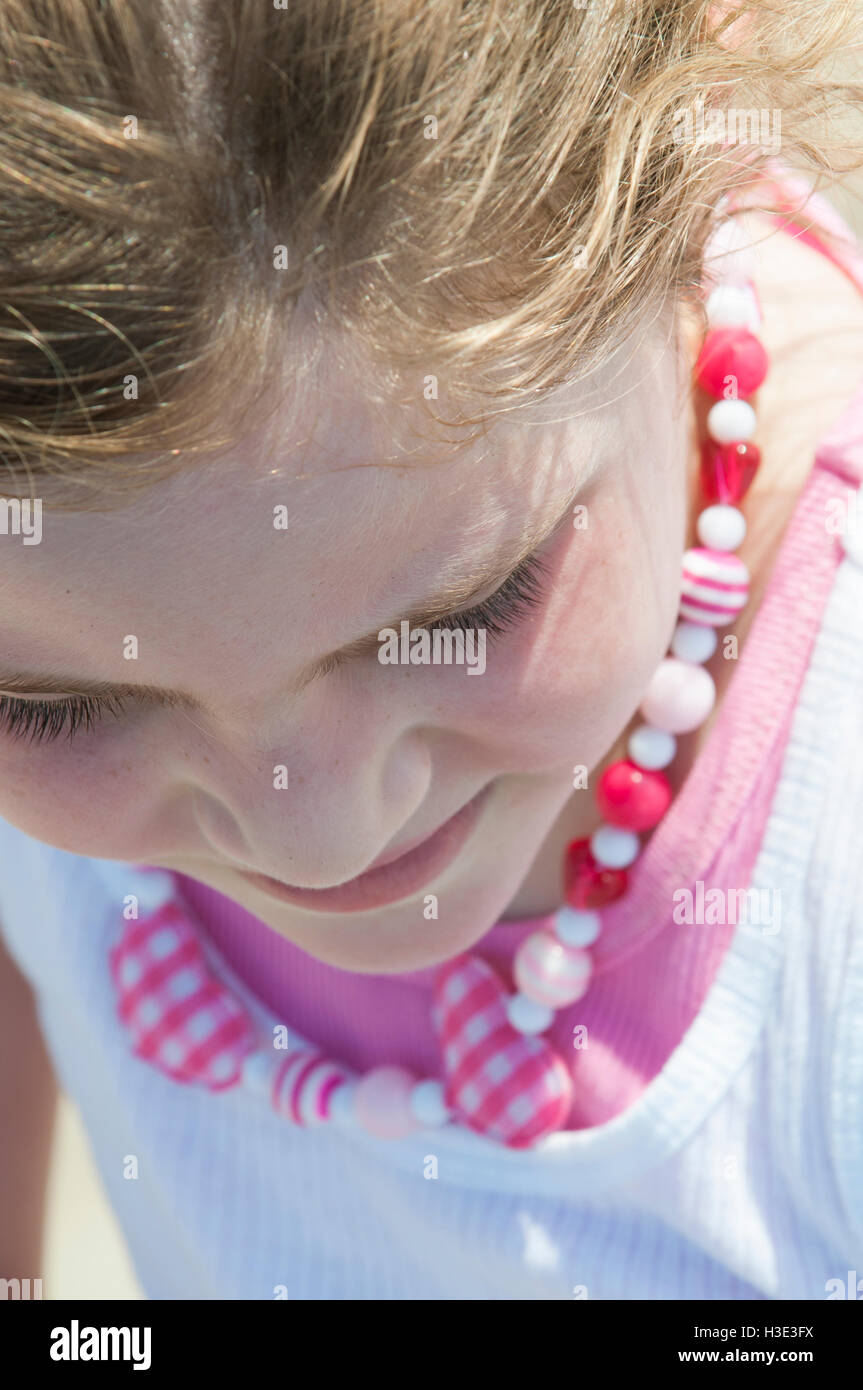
[110,236,767,1148]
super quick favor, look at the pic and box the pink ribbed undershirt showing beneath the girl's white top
[171,179,863,1129]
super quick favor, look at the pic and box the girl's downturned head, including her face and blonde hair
[0,0,845,970]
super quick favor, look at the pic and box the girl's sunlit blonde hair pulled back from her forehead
[0,0,860,505]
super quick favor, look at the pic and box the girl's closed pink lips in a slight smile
[238,785,489,912]
